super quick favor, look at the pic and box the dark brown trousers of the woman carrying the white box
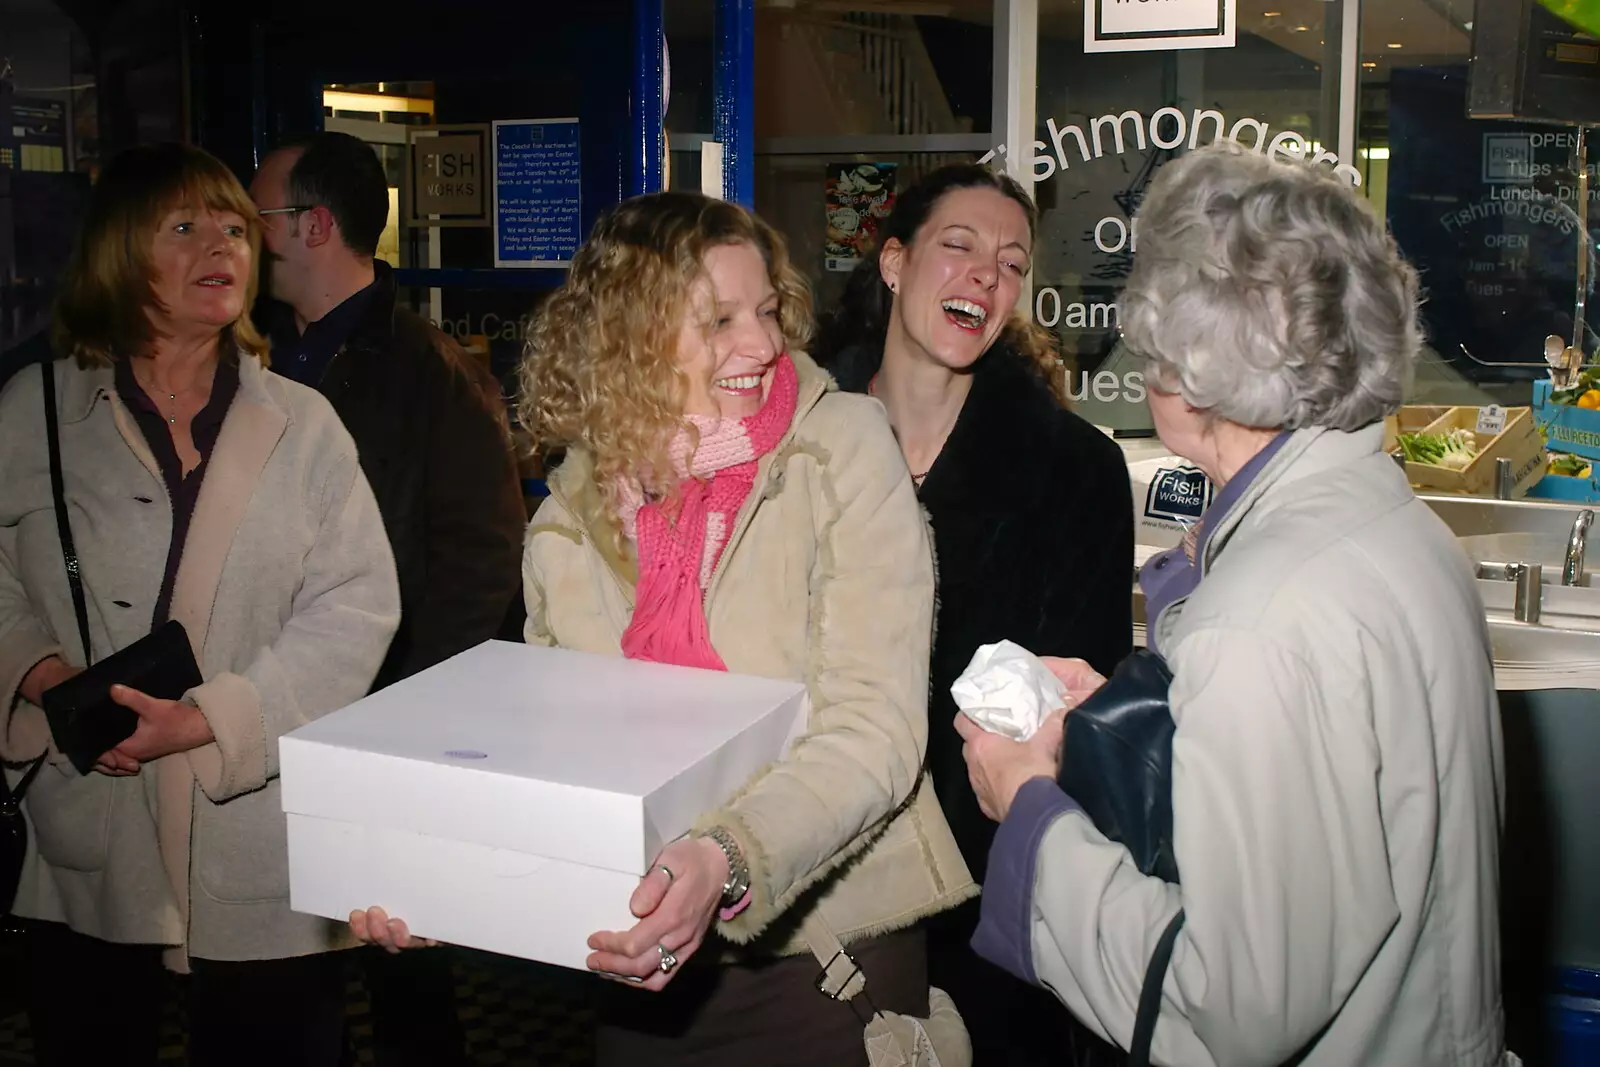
[595,929,928,1067]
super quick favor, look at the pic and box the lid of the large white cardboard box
[278,641,808,873]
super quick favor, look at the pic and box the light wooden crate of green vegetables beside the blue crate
[1397,408,1546,496]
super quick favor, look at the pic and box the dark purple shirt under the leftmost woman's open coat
[114,357,238,630]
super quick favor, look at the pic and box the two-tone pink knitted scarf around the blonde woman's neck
[619,355,800,670]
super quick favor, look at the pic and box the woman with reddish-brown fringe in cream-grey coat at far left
[0,146,400,1067]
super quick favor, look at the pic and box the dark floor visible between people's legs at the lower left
[0,949,594,1067]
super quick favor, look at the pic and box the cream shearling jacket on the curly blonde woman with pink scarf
[523,354,978,959]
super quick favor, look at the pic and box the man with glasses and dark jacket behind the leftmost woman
[250,133,526,1067]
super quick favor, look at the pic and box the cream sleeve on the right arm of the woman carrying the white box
[701,418,933,941]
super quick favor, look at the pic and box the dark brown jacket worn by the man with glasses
[266,262,526,689]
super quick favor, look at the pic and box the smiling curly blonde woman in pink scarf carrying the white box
[352,194,976,1067]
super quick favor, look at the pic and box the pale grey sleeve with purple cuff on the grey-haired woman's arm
[976,630,1398,1067]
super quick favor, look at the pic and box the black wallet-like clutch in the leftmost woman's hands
[42,619,202,774]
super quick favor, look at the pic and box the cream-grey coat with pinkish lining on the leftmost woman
[0,357,400,969]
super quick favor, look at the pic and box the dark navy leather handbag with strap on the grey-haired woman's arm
[1056,648,1184,1067]
